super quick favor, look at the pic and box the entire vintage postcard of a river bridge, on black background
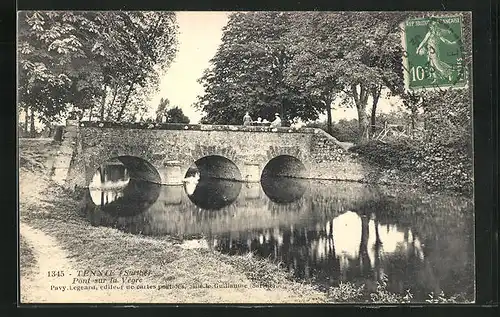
[17,11,475,304]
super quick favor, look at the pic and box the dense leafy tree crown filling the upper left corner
[18,11,112,124]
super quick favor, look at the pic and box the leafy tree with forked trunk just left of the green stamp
[289,12,405,142]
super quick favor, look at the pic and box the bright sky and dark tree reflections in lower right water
[209,211,452,298]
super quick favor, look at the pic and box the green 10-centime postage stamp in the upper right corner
[402,15,467,91]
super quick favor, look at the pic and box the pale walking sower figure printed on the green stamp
[417,21,457,83]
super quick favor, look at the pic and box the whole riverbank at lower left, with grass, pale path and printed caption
[19,137,468,303]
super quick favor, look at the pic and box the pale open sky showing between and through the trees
[150,11,406,123]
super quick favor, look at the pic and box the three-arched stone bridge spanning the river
[60,120,365,188]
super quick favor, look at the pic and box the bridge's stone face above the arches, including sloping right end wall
[68,122,374,188]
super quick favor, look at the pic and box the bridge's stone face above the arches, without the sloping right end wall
[72,123,312,186]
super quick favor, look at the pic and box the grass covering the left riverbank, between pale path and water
[16,137,468,303]
